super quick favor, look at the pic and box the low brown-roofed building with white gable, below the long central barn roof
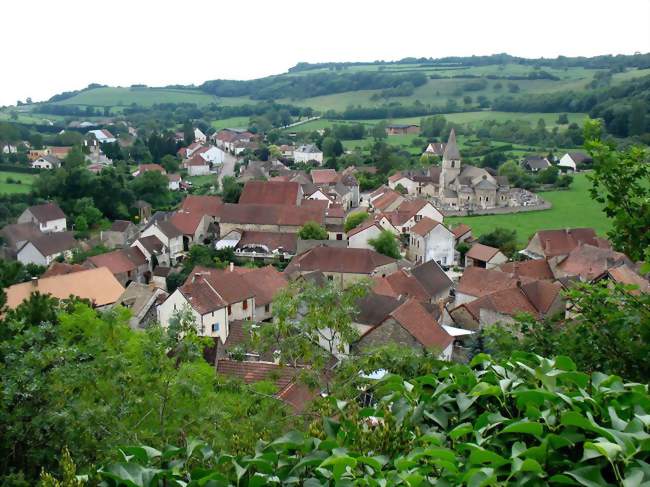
[215,230,298,262]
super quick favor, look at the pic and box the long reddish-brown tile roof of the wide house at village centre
[285,246,396,274]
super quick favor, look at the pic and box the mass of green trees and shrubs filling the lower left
[0,296,287,485]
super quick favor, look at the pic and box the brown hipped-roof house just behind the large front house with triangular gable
[373,260,453,304]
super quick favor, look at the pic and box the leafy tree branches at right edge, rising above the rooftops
[584,120,650,260]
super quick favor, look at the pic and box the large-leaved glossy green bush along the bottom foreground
[69,353,650,486]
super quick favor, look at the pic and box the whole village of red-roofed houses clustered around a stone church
[0,126,650,416]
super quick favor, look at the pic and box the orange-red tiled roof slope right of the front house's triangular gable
[390,299,454,351]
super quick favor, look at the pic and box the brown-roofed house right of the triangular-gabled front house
[449,281,566,330]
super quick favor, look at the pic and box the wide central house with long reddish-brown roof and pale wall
[285,245,397,286]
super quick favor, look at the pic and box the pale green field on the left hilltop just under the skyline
[51,87,217,107]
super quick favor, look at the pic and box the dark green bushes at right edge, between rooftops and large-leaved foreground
[470,282,650,383]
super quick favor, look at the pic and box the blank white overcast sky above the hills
[0,0,650,106]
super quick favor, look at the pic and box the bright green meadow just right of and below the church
[445,173,611,248]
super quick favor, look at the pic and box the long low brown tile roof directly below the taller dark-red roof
[220,203,325,227]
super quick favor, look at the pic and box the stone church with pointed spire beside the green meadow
[388,129,512,209]
